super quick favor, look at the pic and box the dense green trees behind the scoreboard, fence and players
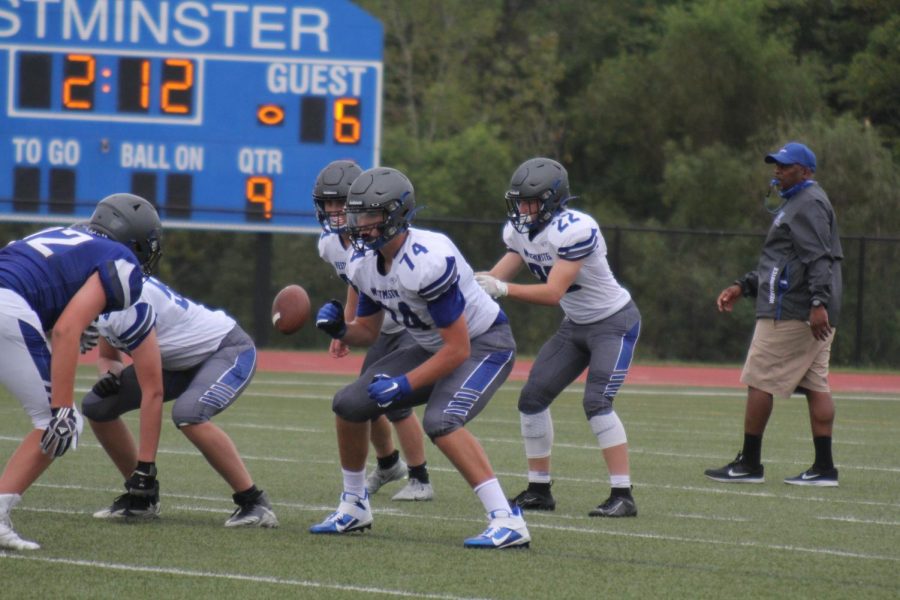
[6,0,900,365]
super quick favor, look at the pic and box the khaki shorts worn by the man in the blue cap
[741,319,835,398]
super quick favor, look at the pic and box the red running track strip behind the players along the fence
[251,350,900,395]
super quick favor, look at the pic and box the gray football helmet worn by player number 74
[346,167,416,251]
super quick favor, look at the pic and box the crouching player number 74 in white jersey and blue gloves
[310,167,531,548]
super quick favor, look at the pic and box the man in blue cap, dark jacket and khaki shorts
[706,142,843,487]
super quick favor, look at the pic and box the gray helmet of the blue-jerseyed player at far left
[88,194,162,276]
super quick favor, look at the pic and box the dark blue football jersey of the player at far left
[0,227,143,331]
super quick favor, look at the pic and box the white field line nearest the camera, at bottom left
[0,550,488,600]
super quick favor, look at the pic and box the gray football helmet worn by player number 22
[506,158,570,233]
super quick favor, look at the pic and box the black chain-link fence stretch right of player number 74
[410,219,900,367]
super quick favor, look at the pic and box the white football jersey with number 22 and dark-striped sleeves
[503,209,631,324]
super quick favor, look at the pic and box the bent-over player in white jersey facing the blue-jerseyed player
[82,277,278,527]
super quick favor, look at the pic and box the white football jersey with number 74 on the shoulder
[347,228,500,351]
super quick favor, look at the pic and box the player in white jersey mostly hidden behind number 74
[313,160,434,500]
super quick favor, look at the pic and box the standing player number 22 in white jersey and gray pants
[476,158,641,517]
